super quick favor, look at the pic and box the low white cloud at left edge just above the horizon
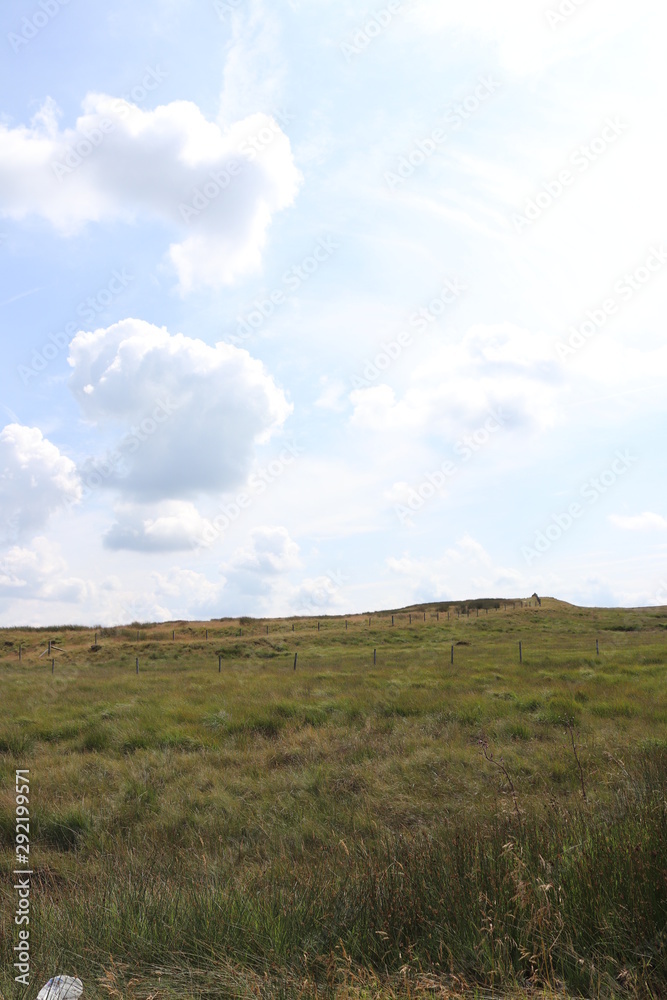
[0,536,89,603]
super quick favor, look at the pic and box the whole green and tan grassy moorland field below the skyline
[0,598,667,1000]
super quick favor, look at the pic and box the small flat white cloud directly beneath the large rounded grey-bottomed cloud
[104,500,210,552]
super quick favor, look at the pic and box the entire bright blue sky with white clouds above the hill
[0,0,667,625]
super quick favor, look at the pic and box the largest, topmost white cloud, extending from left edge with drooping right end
[0,94,301,293]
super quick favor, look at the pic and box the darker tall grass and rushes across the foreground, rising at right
[3,751,667,997]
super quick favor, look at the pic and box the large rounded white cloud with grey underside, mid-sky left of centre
[69,319,291,500]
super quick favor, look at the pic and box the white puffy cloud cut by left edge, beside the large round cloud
[0,424,82,539]
